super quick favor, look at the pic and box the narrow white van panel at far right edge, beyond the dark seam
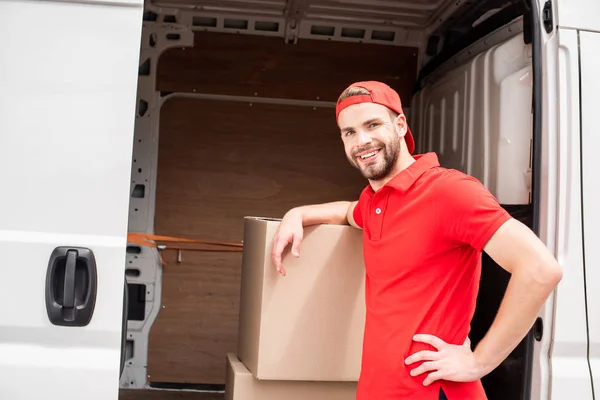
[580,28,600,391]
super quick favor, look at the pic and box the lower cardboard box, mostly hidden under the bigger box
[225,353,356,400]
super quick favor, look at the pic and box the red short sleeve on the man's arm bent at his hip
[435,170,511,251]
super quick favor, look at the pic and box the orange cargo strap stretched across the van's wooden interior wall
[127,232,244,265]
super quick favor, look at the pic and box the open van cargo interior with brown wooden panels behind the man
[120,0,540,400]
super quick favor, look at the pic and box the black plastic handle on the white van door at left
[46,247,97,327]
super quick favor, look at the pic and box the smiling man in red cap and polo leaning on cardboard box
[272,82,562,400]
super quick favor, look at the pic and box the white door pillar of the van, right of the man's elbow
[543,30,592,400]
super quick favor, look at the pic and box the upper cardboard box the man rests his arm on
[237,217,365,382]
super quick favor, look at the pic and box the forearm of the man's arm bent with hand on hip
[474,270,558,376]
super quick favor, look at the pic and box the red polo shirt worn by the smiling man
[354,153,511,400]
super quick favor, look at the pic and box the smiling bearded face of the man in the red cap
[338,103,404,181]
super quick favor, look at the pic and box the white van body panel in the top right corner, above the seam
[556,0,600,32]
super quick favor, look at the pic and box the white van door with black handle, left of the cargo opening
[0,0,143,400]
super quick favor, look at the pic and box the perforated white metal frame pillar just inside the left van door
[120,21,194,389]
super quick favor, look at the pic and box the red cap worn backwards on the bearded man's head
[335,81,415,154]
